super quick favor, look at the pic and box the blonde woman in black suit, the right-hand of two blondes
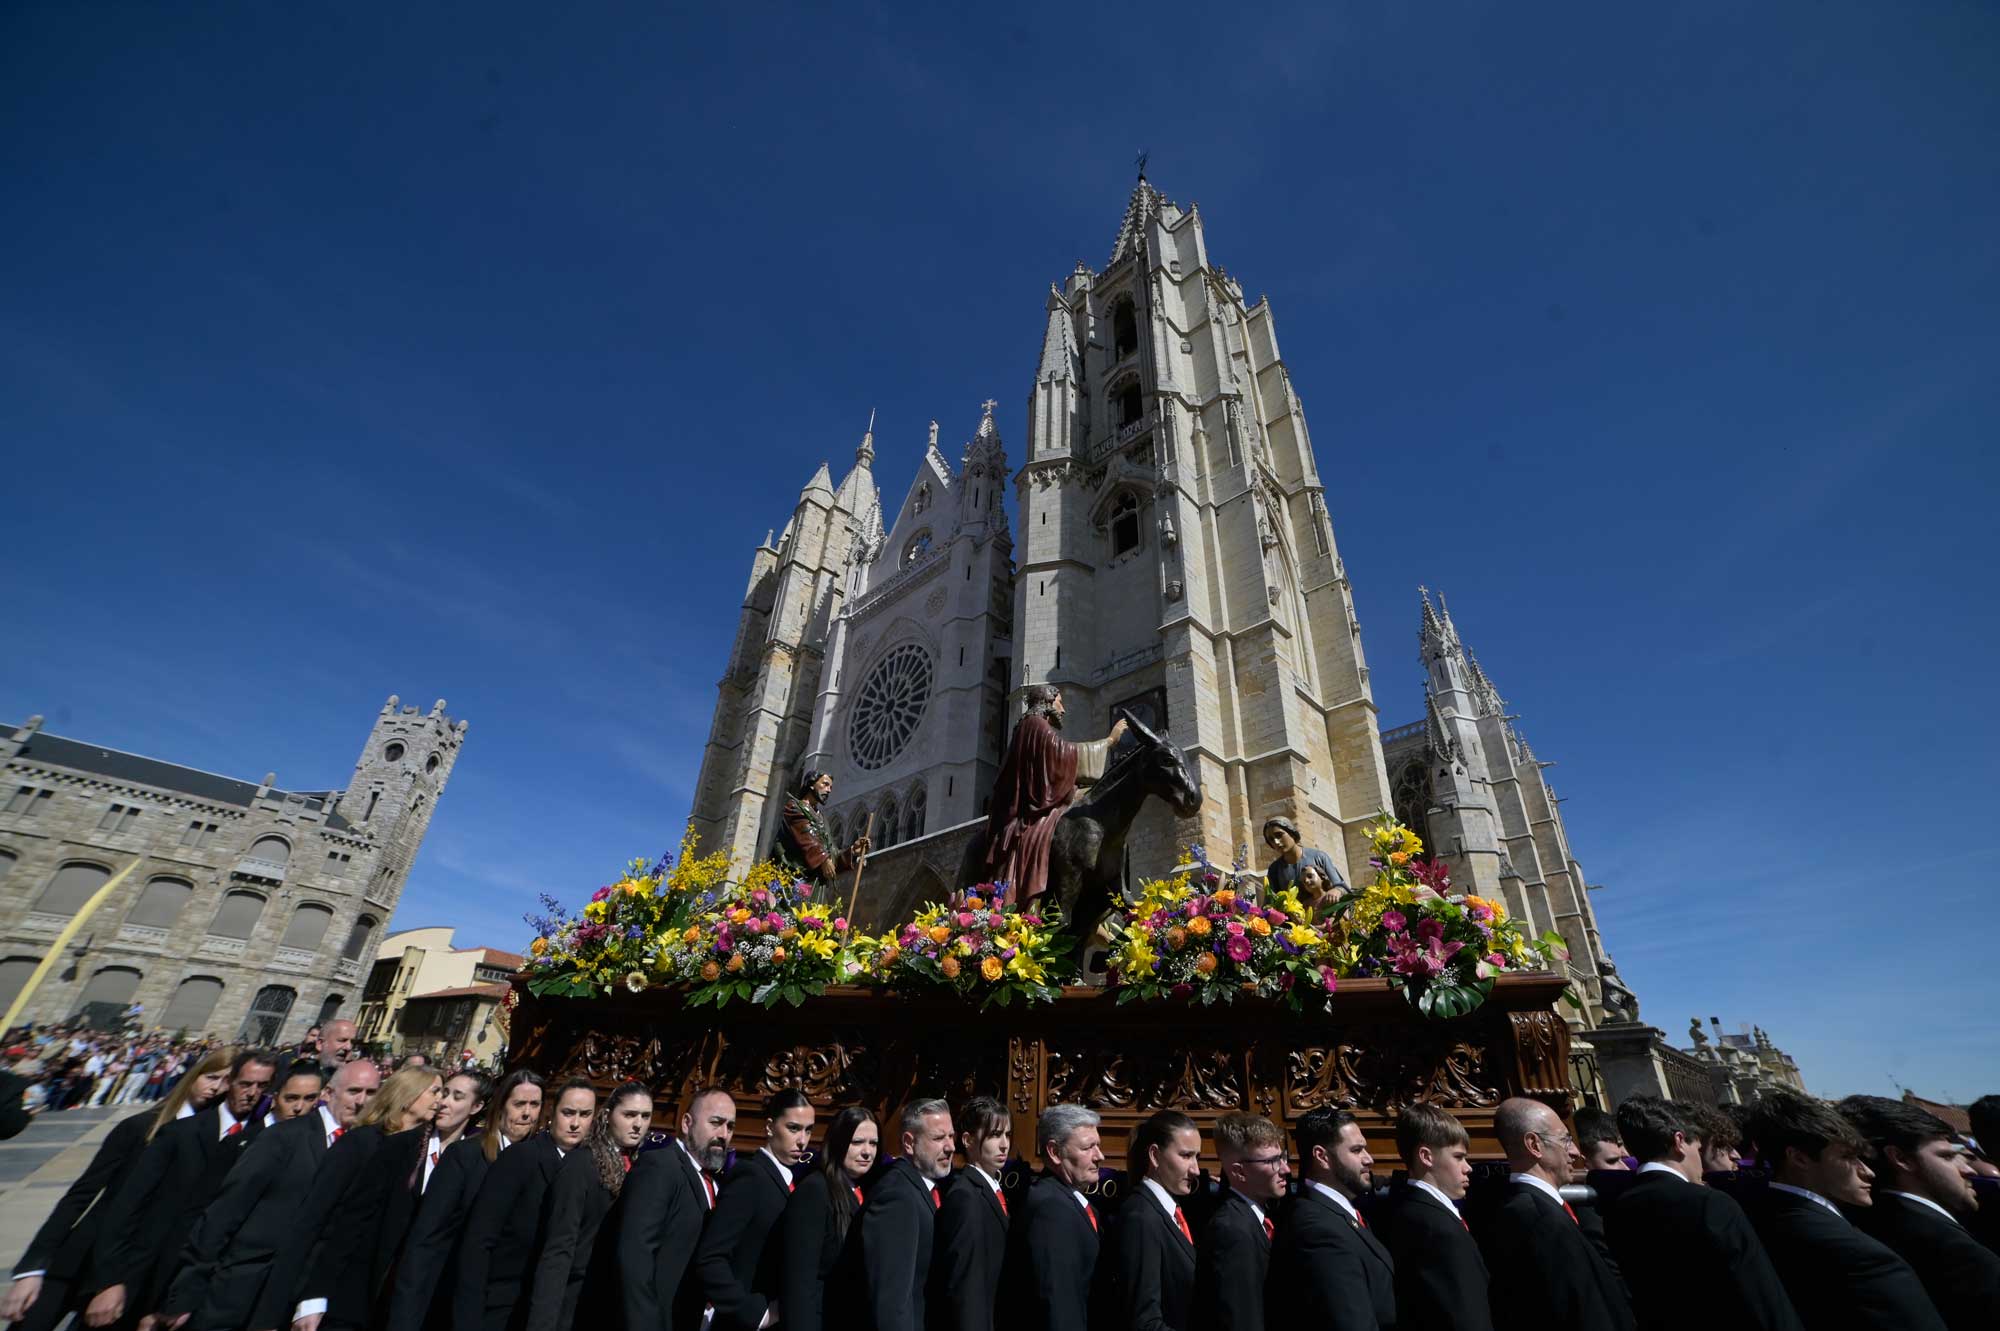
[270,1065,444,1331]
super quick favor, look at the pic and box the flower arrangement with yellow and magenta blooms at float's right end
[1326,817,1578,1017]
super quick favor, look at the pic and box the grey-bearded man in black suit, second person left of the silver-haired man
[852,1099,952,1331]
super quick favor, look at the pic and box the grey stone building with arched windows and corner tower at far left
[0,697,466,1043]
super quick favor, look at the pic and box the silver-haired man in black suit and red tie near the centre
[1002,1105,1104,1331]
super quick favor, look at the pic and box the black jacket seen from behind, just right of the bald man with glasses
[1604,1169,1802,1331]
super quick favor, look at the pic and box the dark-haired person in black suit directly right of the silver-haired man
[1096,1109,1202,1331]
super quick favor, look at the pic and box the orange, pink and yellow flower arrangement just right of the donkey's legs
[1106,845,1338,1007]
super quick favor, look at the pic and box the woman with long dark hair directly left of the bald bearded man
[526,1081,652,1331]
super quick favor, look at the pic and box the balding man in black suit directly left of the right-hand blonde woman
[160,1061,382,1331]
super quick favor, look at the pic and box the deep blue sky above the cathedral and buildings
[0,4,2000,1097]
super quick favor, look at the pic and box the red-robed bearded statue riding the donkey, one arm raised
[986,683,1126,907]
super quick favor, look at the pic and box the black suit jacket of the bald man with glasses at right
[1480,1183,1636,1331]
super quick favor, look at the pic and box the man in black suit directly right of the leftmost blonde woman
[84,1049,278,1327]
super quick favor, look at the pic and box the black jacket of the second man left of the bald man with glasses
[1264,1185,1396,1331]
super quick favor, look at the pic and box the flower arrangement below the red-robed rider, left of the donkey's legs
[872,883,1074,1009]
